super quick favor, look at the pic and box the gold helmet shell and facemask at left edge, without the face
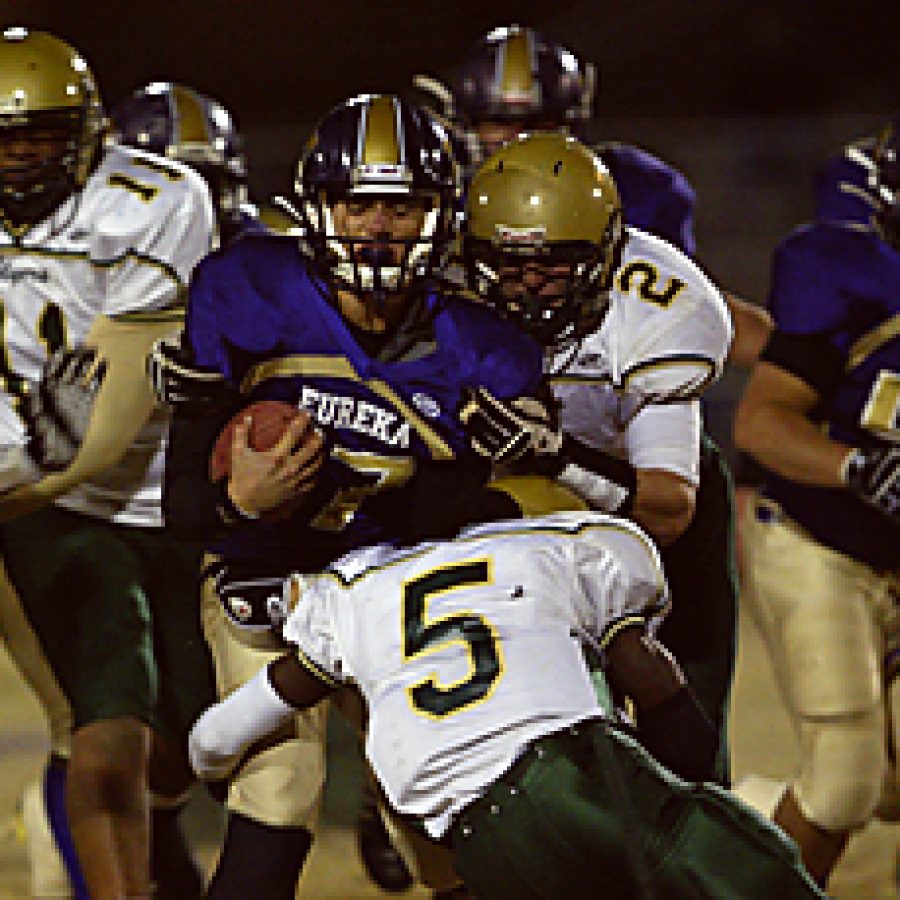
[0,27,105,222]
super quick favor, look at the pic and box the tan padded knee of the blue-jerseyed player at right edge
[794,712,888,831]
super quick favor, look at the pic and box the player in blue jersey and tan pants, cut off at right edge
[735,121,900,885]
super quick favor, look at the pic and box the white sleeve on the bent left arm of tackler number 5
[188,666,297,780]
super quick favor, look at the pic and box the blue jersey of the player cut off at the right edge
[766,223,900,568]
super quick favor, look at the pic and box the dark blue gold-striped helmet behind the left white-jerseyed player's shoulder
[111,81,249,237]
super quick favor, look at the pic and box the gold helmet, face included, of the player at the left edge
[0,28,104,225]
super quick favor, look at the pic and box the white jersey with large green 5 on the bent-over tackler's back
[284,512,668,837]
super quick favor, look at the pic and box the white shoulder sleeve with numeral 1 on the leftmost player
[91,150,214,317]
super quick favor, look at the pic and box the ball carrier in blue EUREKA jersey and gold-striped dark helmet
[158,95,541,900]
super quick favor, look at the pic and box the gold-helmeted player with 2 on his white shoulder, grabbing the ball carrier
[463,132,737,782]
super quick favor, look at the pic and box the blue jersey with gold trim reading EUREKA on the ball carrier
[186,236,542,568]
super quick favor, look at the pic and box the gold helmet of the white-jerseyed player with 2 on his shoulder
[463,132,625,346]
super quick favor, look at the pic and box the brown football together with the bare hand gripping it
[209,400,326,520]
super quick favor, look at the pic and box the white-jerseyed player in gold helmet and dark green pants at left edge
[0,28,212,900]
